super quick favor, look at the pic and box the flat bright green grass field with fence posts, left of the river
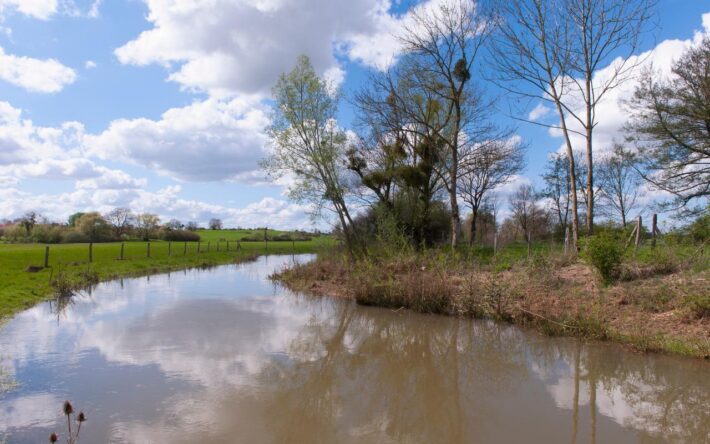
[0,230,334,319]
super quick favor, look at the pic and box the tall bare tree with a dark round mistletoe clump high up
[392,0,493,246]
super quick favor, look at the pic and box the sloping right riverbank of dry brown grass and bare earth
[274,246,710,358]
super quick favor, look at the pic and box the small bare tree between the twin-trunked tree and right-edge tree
[598,143,642,227]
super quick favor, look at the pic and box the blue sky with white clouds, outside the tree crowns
[0,0,710,228]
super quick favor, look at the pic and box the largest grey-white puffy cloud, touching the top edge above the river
[115,0,448,96]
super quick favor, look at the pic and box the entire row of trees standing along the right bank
[262,0,710,254]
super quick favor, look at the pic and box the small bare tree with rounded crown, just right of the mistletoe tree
[458,139,524,245]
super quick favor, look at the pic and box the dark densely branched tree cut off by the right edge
[629,37,710,213]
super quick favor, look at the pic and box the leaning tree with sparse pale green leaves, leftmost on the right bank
[262,56,357,254]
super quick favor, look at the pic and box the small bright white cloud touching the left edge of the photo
[0,48,76,93]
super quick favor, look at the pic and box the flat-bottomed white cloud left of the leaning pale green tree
[85,97,268,181]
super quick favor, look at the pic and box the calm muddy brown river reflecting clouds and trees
[0,256,710,443]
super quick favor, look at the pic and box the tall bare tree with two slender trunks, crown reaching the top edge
[491,0,655,248]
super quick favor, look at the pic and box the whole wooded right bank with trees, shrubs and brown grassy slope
[264,0,710,357]
